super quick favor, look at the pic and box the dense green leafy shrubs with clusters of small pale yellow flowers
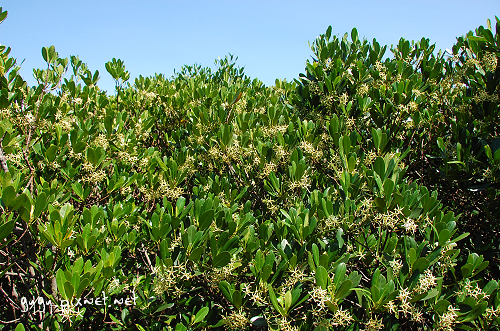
[0,9,500,331]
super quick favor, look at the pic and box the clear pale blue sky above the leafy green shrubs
[0,0,500,92]
